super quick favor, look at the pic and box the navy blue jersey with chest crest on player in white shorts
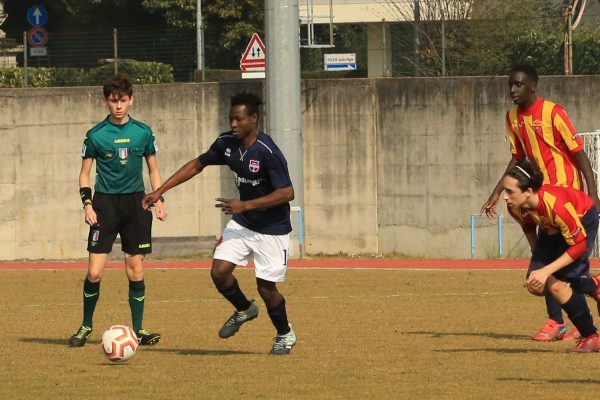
[198,131,292,235]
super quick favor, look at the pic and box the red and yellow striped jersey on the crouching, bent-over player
[508,185,594,260]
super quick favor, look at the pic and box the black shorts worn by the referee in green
[87,192,152,255]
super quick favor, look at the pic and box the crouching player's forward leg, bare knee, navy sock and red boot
[547,276,600,353]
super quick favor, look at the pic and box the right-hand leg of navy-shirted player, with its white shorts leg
[252,234,296,355]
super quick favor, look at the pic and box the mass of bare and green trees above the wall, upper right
[390,0,562,76]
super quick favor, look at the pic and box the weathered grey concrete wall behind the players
[0,76,600,260]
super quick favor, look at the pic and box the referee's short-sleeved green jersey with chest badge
[81,117,158,194]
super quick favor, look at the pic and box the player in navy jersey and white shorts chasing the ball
[142,93,296,355]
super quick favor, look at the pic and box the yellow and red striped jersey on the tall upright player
[506,97,583,190]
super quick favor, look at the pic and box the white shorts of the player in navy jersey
[213,220,290,282]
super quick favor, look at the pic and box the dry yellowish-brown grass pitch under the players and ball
[0,269,600,400]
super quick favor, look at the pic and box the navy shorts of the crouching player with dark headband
[527,207,598,282]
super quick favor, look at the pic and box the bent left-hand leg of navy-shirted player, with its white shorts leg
[210,220,258,339]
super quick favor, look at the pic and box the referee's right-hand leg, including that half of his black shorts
[120,193,161,346]
